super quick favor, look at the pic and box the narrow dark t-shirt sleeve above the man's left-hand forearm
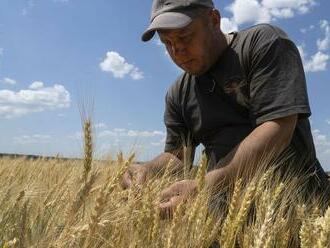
[164,87,188,152]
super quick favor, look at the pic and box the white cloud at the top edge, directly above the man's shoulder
[223,0,315,32]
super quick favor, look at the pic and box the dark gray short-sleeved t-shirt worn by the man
[164,24,324,179]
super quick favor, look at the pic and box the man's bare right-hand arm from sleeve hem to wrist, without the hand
[206,115,297,188]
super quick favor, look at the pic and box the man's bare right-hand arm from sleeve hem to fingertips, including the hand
[159,115,297,216]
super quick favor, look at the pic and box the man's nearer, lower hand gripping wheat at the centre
[158,180,197,218]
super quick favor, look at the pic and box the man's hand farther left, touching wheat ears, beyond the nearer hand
[120,164,150,189]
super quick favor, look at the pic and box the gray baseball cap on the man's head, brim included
[142,0,214,41]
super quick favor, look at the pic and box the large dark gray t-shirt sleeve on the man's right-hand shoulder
[250,37,311,125]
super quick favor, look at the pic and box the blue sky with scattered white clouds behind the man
[0,0,330,170]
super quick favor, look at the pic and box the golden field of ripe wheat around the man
[0,119,330,248]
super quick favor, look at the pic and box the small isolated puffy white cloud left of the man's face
[100,51,143,80]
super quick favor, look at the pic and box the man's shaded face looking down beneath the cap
[158,15,213,75]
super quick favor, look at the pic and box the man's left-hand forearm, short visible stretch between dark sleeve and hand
[144,152,183,176]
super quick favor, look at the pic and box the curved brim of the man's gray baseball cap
[142,12,192,41]
